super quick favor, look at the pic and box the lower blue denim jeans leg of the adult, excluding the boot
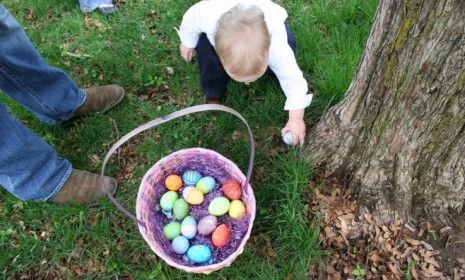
[0,104,72,201]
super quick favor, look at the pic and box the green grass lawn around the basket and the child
[0,0,376,279]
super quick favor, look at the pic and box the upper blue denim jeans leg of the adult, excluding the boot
[0,4,85,124]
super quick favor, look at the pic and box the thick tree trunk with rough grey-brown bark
[304,0,465,222]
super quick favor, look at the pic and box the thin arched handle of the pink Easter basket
[101,104,255,227]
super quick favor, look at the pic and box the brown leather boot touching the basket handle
[50,169,117,204]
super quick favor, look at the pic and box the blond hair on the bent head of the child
[215,5,270,77]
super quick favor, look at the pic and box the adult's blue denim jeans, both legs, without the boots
[0,4,85,201]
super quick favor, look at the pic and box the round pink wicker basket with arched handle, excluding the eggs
[102,105,256,273]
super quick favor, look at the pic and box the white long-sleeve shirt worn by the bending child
[178,0,313,110]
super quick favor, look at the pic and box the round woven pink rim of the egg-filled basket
[136,148,256,273]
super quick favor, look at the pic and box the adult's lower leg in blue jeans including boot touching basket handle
[0,104,117,203]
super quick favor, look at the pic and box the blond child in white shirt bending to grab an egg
[178,0,313,146]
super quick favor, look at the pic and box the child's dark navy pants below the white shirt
[195,22,296,99]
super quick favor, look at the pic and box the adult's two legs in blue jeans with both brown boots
[0,4,118,202]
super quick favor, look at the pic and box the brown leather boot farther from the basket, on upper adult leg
[74,85,125,117]
